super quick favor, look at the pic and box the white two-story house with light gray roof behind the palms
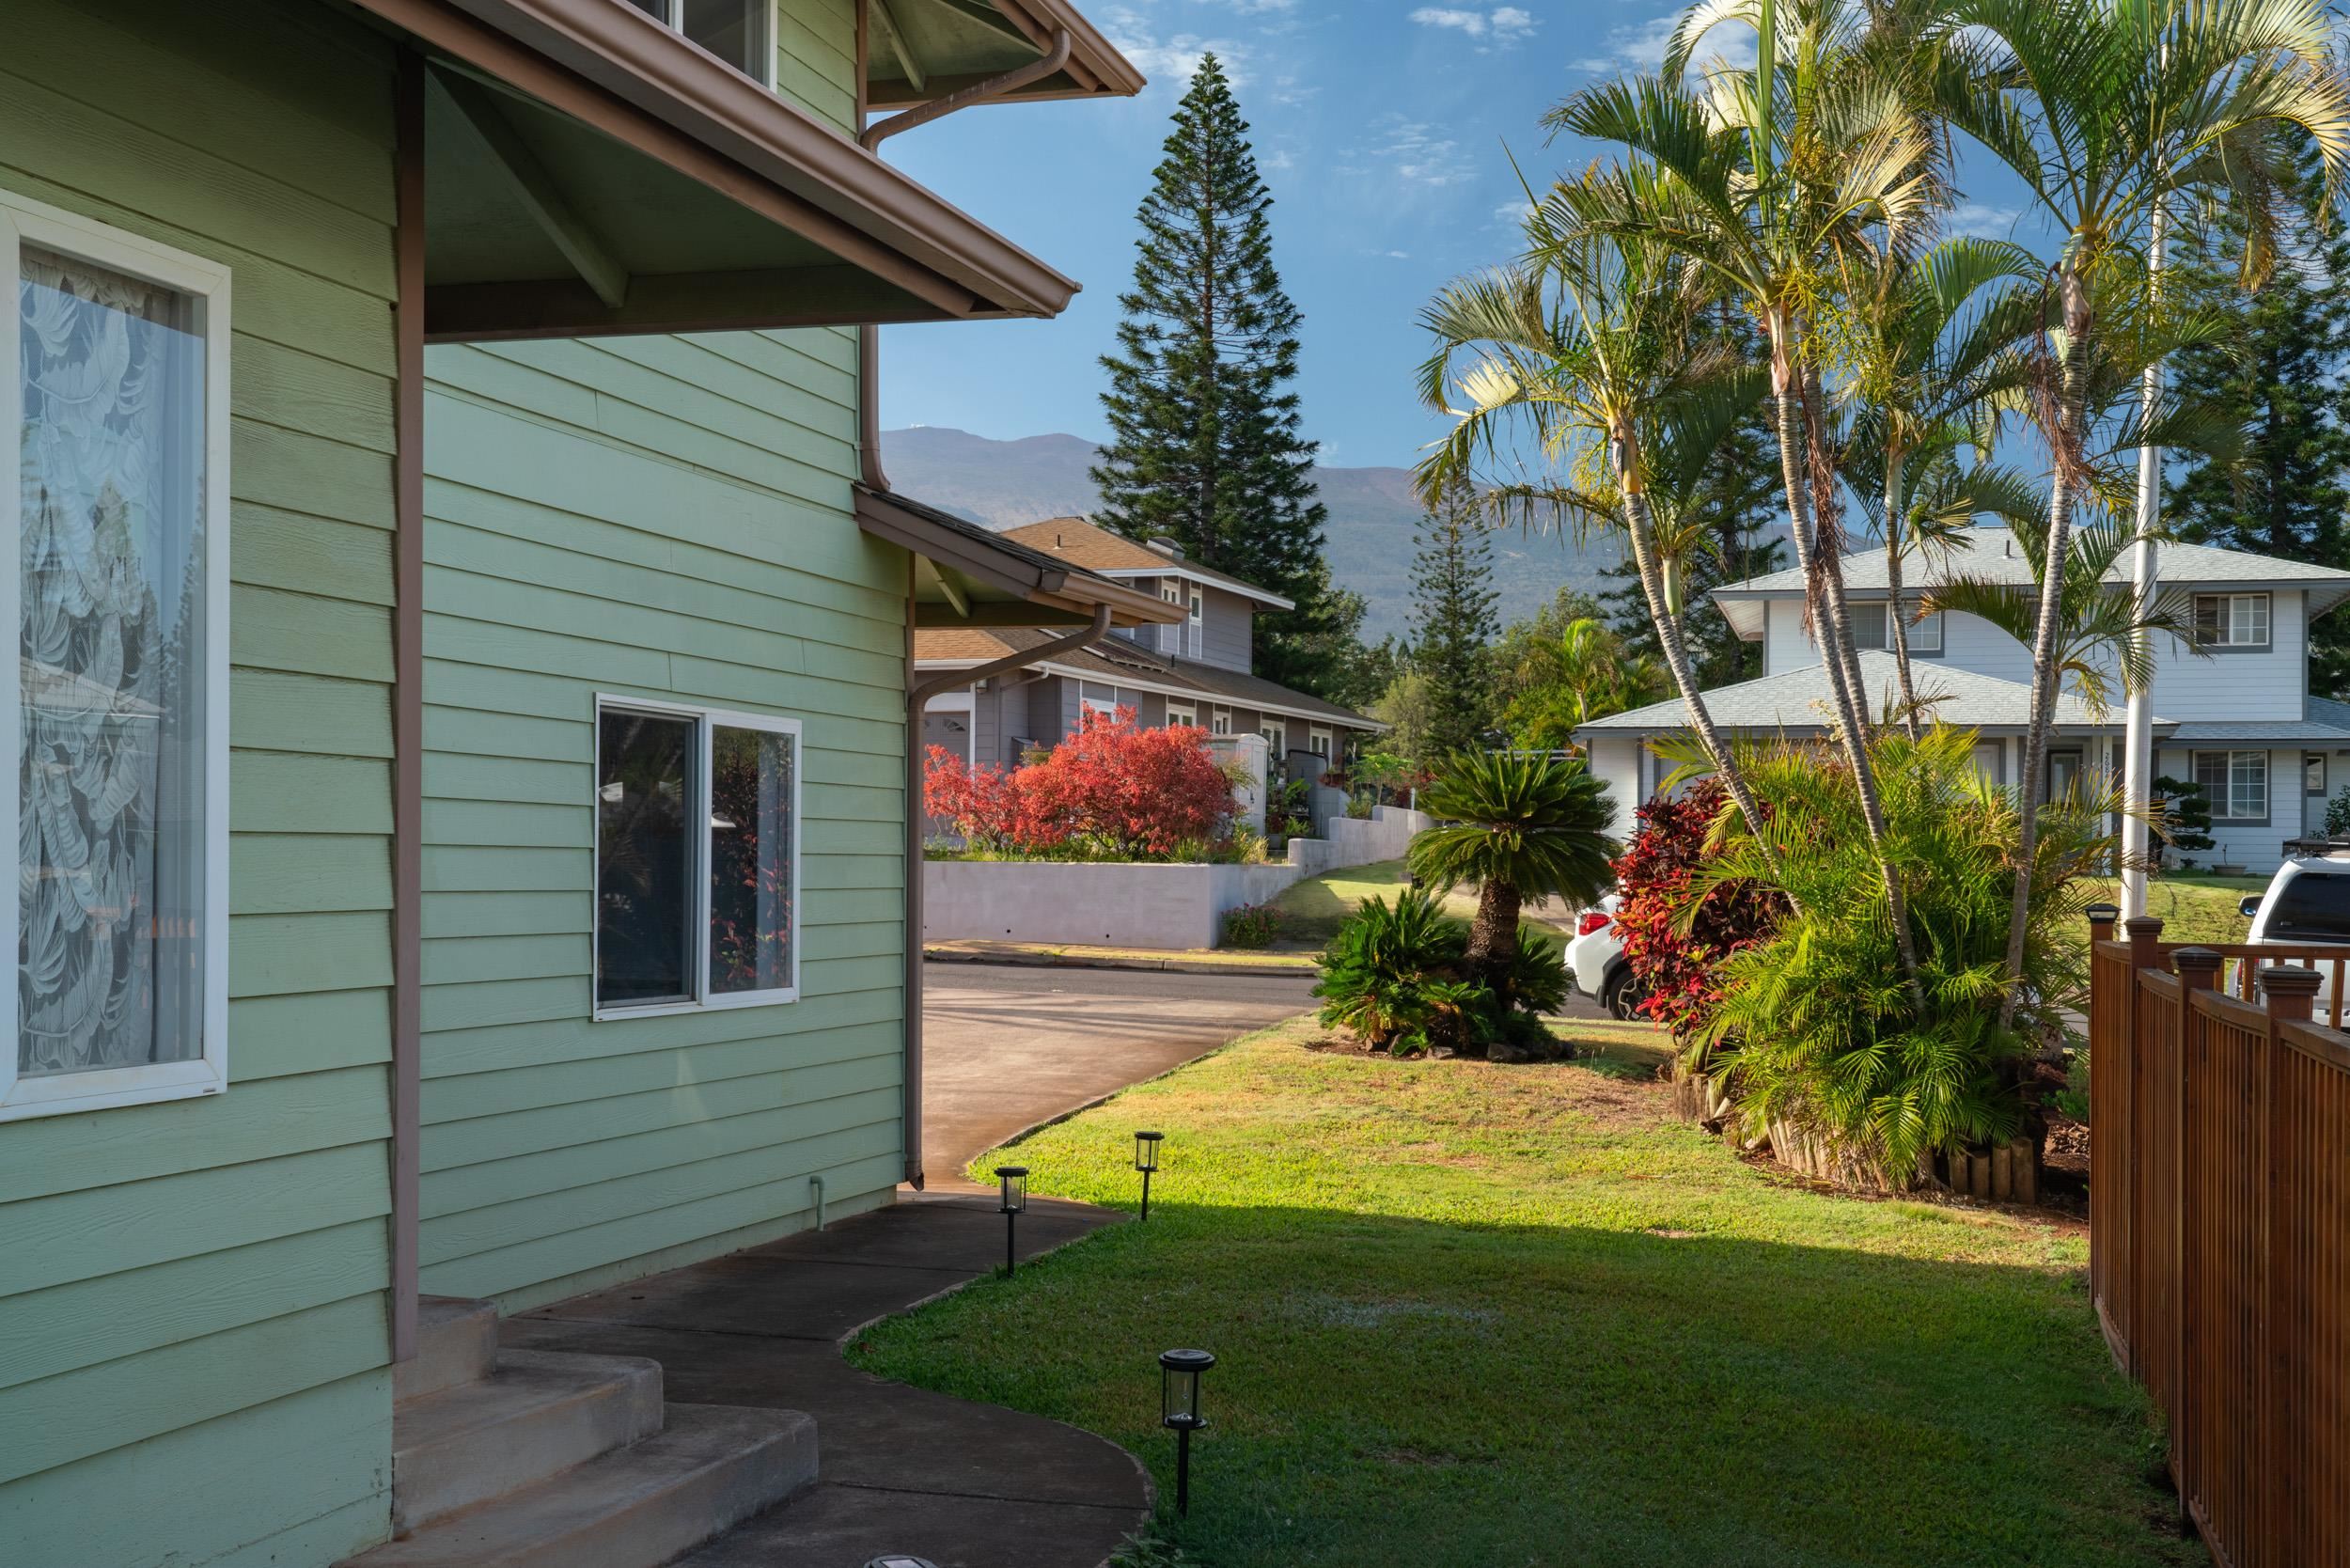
[1577,526,2350,870]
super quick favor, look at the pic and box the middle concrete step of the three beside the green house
[393,1349,661,1532]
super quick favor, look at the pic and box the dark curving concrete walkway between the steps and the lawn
[501,1197,1152,1568]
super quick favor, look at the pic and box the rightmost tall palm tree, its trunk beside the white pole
[1936,0,2350,1020]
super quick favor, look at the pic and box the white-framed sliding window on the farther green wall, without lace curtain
[595,696,802,1018]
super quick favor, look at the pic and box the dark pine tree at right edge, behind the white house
[2162,134,2350,700]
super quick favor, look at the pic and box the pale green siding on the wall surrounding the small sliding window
[423,312,905,1307]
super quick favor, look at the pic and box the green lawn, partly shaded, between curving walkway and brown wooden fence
[855,1020,2204,1568]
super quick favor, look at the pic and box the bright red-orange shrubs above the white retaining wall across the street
[921,708,1234,860]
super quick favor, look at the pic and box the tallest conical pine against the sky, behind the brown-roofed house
[1093,55,1354,691]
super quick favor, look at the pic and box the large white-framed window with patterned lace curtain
[0,193,230,1121]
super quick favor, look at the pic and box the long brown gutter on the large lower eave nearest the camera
[352,0,1076,315]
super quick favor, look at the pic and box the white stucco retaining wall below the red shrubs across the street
[921,807,1432,952]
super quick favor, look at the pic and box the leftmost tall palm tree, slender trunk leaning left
[1418,227,1761,879]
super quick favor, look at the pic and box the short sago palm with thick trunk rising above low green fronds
[1408,752,1622,995]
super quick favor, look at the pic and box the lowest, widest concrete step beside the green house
[343,1405,816,1568]
